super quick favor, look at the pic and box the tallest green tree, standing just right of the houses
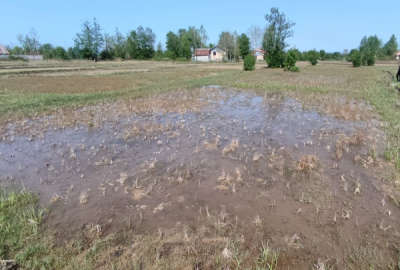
[263,8,295,67]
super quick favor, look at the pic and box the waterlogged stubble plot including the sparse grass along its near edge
[0,81,400,269]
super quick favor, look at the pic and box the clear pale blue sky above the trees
[0,0,400,51]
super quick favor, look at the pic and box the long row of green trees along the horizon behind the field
[4,12,398,68]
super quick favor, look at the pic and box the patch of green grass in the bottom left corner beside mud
[0,189,61,269]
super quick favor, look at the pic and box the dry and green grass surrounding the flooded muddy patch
[0,61,400,270]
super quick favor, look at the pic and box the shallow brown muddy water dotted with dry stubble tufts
[0,87,400,265]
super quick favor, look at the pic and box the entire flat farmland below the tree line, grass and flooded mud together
[0,61,400,270]
